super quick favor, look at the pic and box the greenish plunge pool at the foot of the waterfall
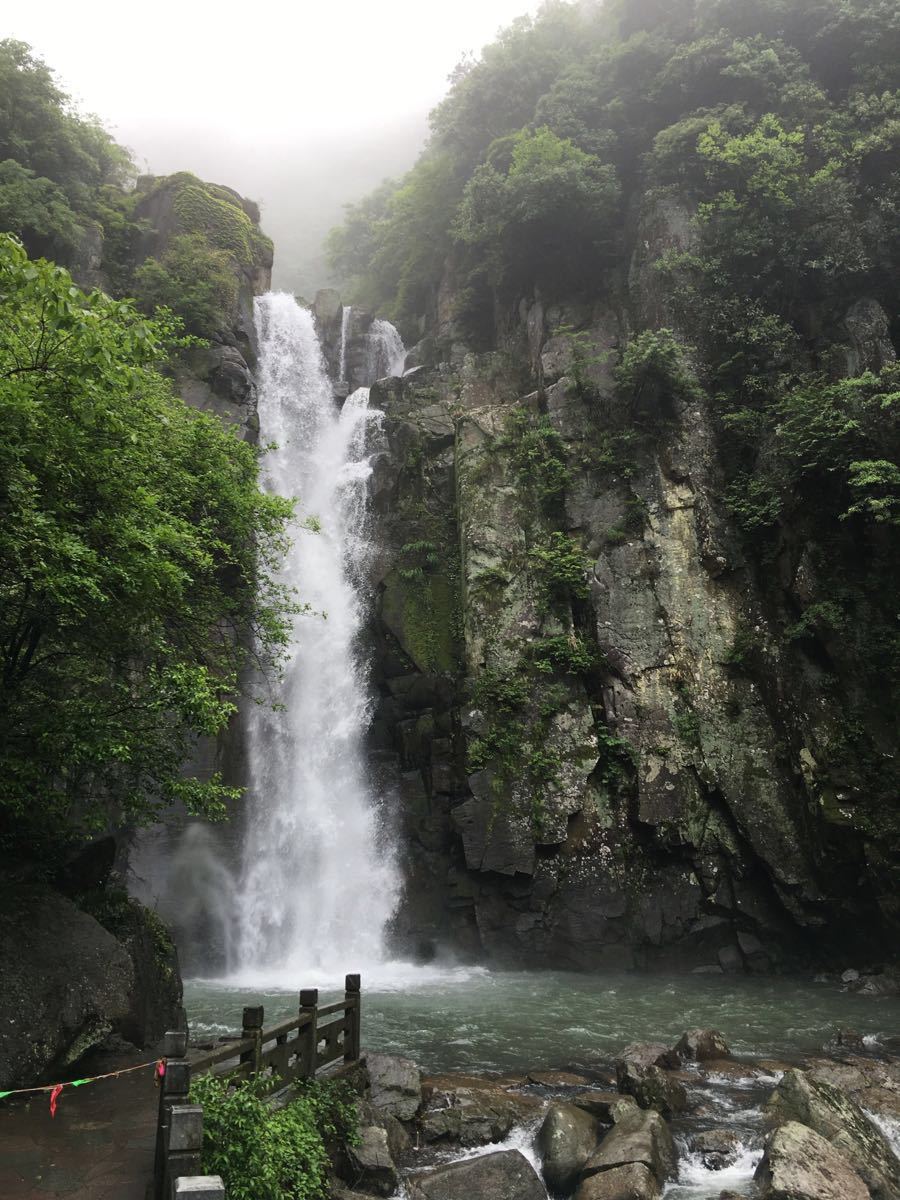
[186,964,900,1072]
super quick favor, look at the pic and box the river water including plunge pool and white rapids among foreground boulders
[186,964,900,1200]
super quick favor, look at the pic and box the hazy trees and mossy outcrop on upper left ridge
[0,38,272,336]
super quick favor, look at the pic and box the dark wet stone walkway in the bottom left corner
[0,1068,158,1200]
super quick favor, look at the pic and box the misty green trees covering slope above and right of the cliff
[331,0,900,691]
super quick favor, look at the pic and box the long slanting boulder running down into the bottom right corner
[766,1070,900,1200]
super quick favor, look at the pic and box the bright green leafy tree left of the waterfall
[0,235,290,842]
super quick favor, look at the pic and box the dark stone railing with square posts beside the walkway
[154,974,361,1200]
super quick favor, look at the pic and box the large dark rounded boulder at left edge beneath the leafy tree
[0,887,134,1088]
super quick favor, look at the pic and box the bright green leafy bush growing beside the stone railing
[191,1074,359,1200]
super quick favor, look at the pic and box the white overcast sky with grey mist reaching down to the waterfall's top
[8,0,539,288]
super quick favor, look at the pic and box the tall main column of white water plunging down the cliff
[232,294,400,986]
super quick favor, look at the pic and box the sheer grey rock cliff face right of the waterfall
[372,189,898,971]
